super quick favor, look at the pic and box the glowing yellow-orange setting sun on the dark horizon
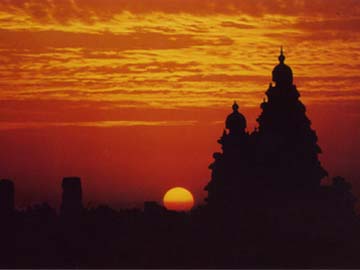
[163,187,194,211]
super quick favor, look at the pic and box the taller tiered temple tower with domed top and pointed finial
[254,48,327,190]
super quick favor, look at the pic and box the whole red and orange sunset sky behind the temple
[0,0,360,207]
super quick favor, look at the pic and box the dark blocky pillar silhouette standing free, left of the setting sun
[61,177,83,218]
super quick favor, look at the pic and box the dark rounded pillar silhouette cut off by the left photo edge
[0,179,15,216]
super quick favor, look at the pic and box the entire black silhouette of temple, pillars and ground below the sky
[0,50,360,268]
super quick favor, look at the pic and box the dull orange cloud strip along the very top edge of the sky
[0,0,360,23]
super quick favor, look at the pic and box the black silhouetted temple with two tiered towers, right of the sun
[205,48,327,207]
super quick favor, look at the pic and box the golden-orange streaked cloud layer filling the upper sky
[0,0,360,122]
